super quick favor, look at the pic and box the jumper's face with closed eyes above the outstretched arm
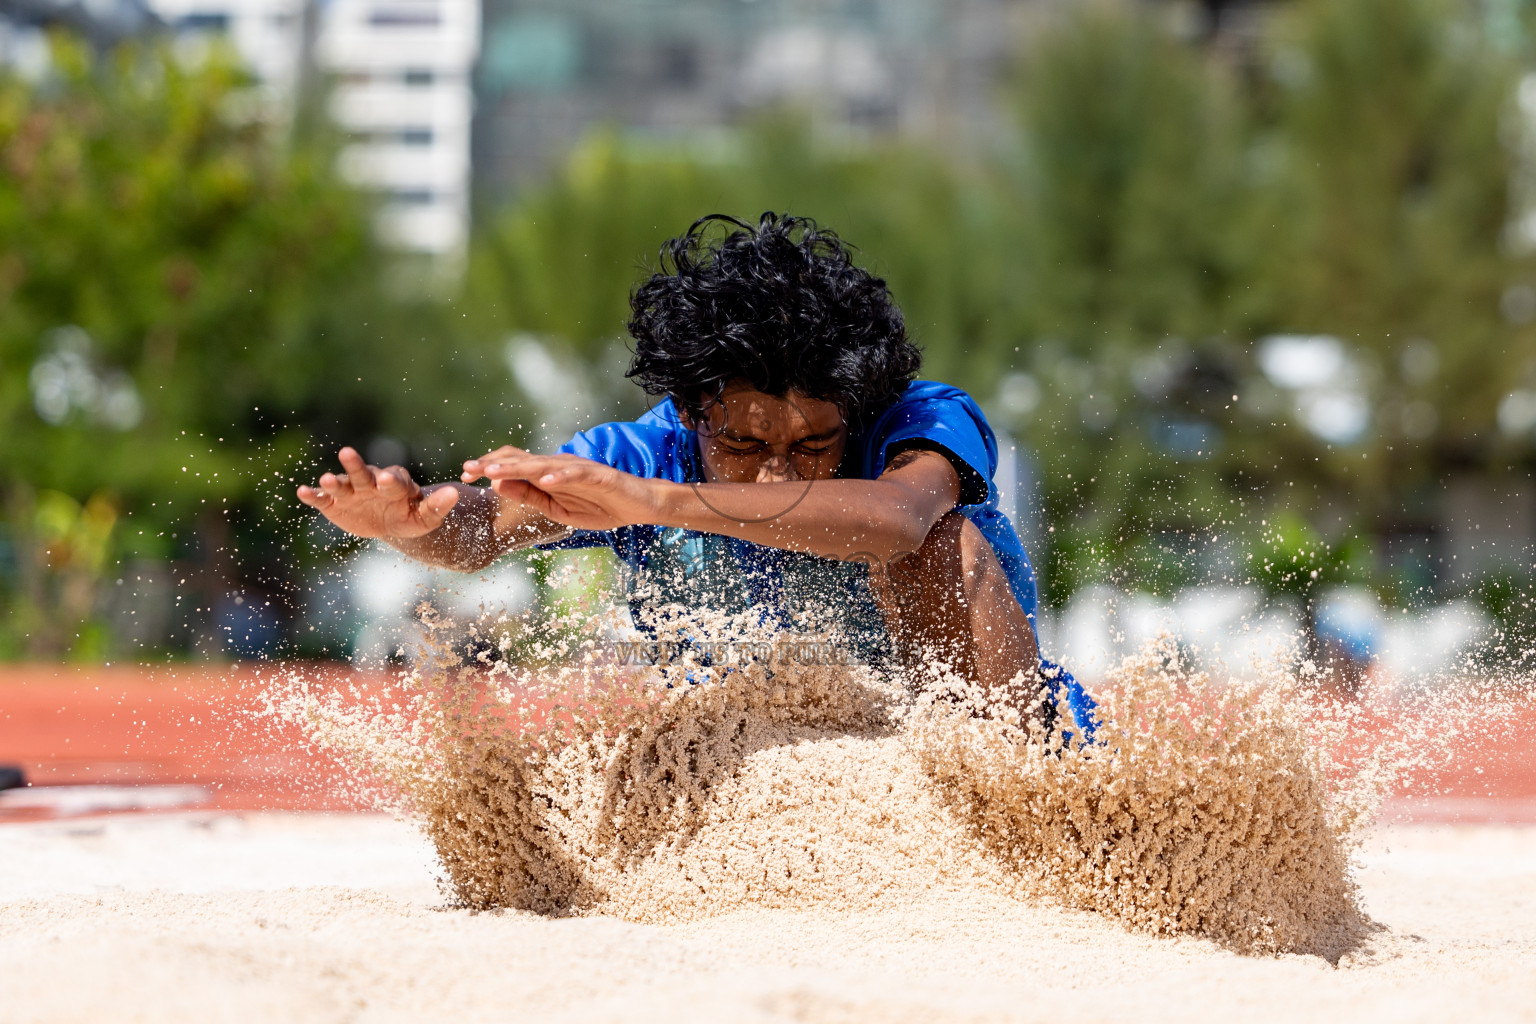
[684,387,848,484]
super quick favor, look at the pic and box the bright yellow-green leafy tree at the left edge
[0,37,466,654]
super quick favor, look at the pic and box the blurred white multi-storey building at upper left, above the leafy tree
[0,0,481,259]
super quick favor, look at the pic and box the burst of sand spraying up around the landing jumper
[264,595,1523,958]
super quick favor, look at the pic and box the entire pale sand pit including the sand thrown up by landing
[0,626,1536,1022]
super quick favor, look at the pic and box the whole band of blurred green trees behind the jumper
[9,0,1536,652]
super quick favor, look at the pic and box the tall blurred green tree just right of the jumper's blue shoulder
[983,3,1255,600]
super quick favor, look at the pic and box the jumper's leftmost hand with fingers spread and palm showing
[298,448,459,540]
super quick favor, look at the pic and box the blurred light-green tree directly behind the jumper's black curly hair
[464,114,1005,420]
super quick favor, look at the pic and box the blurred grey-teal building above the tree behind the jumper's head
[475,0,1049,197]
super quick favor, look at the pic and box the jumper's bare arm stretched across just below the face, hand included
[464,451,960,565]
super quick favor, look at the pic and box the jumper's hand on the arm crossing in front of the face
[464,445,660,530]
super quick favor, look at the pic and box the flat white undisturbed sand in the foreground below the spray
[0,814,1536,1024]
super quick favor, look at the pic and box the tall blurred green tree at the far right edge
[1261,0,1536,500]
